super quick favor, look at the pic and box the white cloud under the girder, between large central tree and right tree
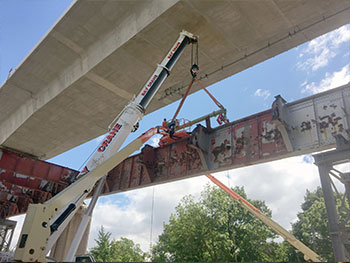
[226,156,319,229]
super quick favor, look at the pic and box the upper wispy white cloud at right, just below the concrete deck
[297,25,350,71]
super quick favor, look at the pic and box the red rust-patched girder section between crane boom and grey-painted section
[100,110,288,194]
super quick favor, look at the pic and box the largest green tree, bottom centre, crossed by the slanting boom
[152,186,280,262]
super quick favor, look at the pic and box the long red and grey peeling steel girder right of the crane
[100,84,350,194]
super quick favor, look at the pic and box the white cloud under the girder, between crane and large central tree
[89,177,208,251]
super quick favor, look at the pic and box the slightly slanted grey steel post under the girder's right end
[318,163,346,261]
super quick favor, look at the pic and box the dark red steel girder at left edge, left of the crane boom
[0,149,78,218]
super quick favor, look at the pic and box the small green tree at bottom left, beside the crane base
[90,226,148,262]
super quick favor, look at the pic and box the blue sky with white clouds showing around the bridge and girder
[0,0,350,254]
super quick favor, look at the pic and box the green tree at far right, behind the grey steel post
[286,187,348,261]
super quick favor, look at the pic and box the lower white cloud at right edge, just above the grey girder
[301,65,350,94]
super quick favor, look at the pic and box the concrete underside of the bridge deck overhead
[0,0,350,159]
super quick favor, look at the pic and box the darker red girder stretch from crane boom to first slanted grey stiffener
[104,139,204,193]
